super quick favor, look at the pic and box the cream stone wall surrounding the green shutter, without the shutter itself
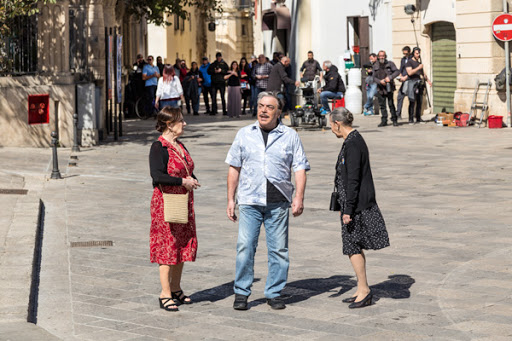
[393,0,511,119]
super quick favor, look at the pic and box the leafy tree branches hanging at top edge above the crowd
[125,0,222,26]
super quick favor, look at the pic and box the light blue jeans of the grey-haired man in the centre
[234,202,290,298]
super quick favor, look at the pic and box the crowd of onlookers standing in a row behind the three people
[133,52,299,117]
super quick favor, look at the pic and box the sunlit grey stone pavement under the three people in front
[1,116,512,341]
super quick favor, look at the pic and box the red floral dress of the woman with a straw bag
[149,136,197,265]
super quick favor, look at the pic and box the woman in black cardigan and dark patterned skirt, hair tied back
[331,107,389,308]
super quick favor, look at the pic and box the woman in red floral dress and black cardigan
[149,107,200,311]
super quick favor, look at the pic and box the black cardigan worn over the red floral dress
[149,141,197,187]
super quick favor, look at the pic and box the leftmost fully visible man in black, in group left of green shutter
[373,50,400,127]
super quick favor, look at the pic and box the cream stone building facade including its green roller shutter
[393,0,510,120]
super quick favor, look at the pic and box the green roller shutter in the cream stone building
[432,22,457,114]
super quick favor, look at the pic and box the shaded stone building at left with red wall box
[0,0,146,147]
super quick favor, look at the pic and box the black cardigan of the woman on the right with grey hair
[336,130,377,216]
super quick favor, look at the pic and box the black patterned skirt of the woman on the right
[341,205,389,255]
